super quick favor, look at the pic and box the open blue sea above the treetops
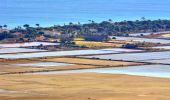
[0,0,170,27]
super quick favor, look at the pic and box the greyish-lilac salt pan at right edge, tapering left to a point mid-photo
[80,51,170,61]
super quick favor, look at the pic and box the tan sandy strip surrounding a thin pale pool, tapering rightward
[0,57,140,74]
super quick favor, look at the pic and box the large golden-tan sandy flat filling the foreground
[0,73,170,100]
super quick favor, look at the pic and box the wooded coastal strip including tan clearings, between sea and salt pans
[0,17,170,43]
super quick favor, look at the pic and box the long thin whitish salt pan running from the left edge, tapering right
[0,48,141,59]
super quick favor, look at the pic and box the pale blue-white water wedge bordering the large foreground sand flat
[29,65,170,78]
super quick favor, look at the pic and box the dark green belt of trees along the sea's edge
[0,18,170,40]
